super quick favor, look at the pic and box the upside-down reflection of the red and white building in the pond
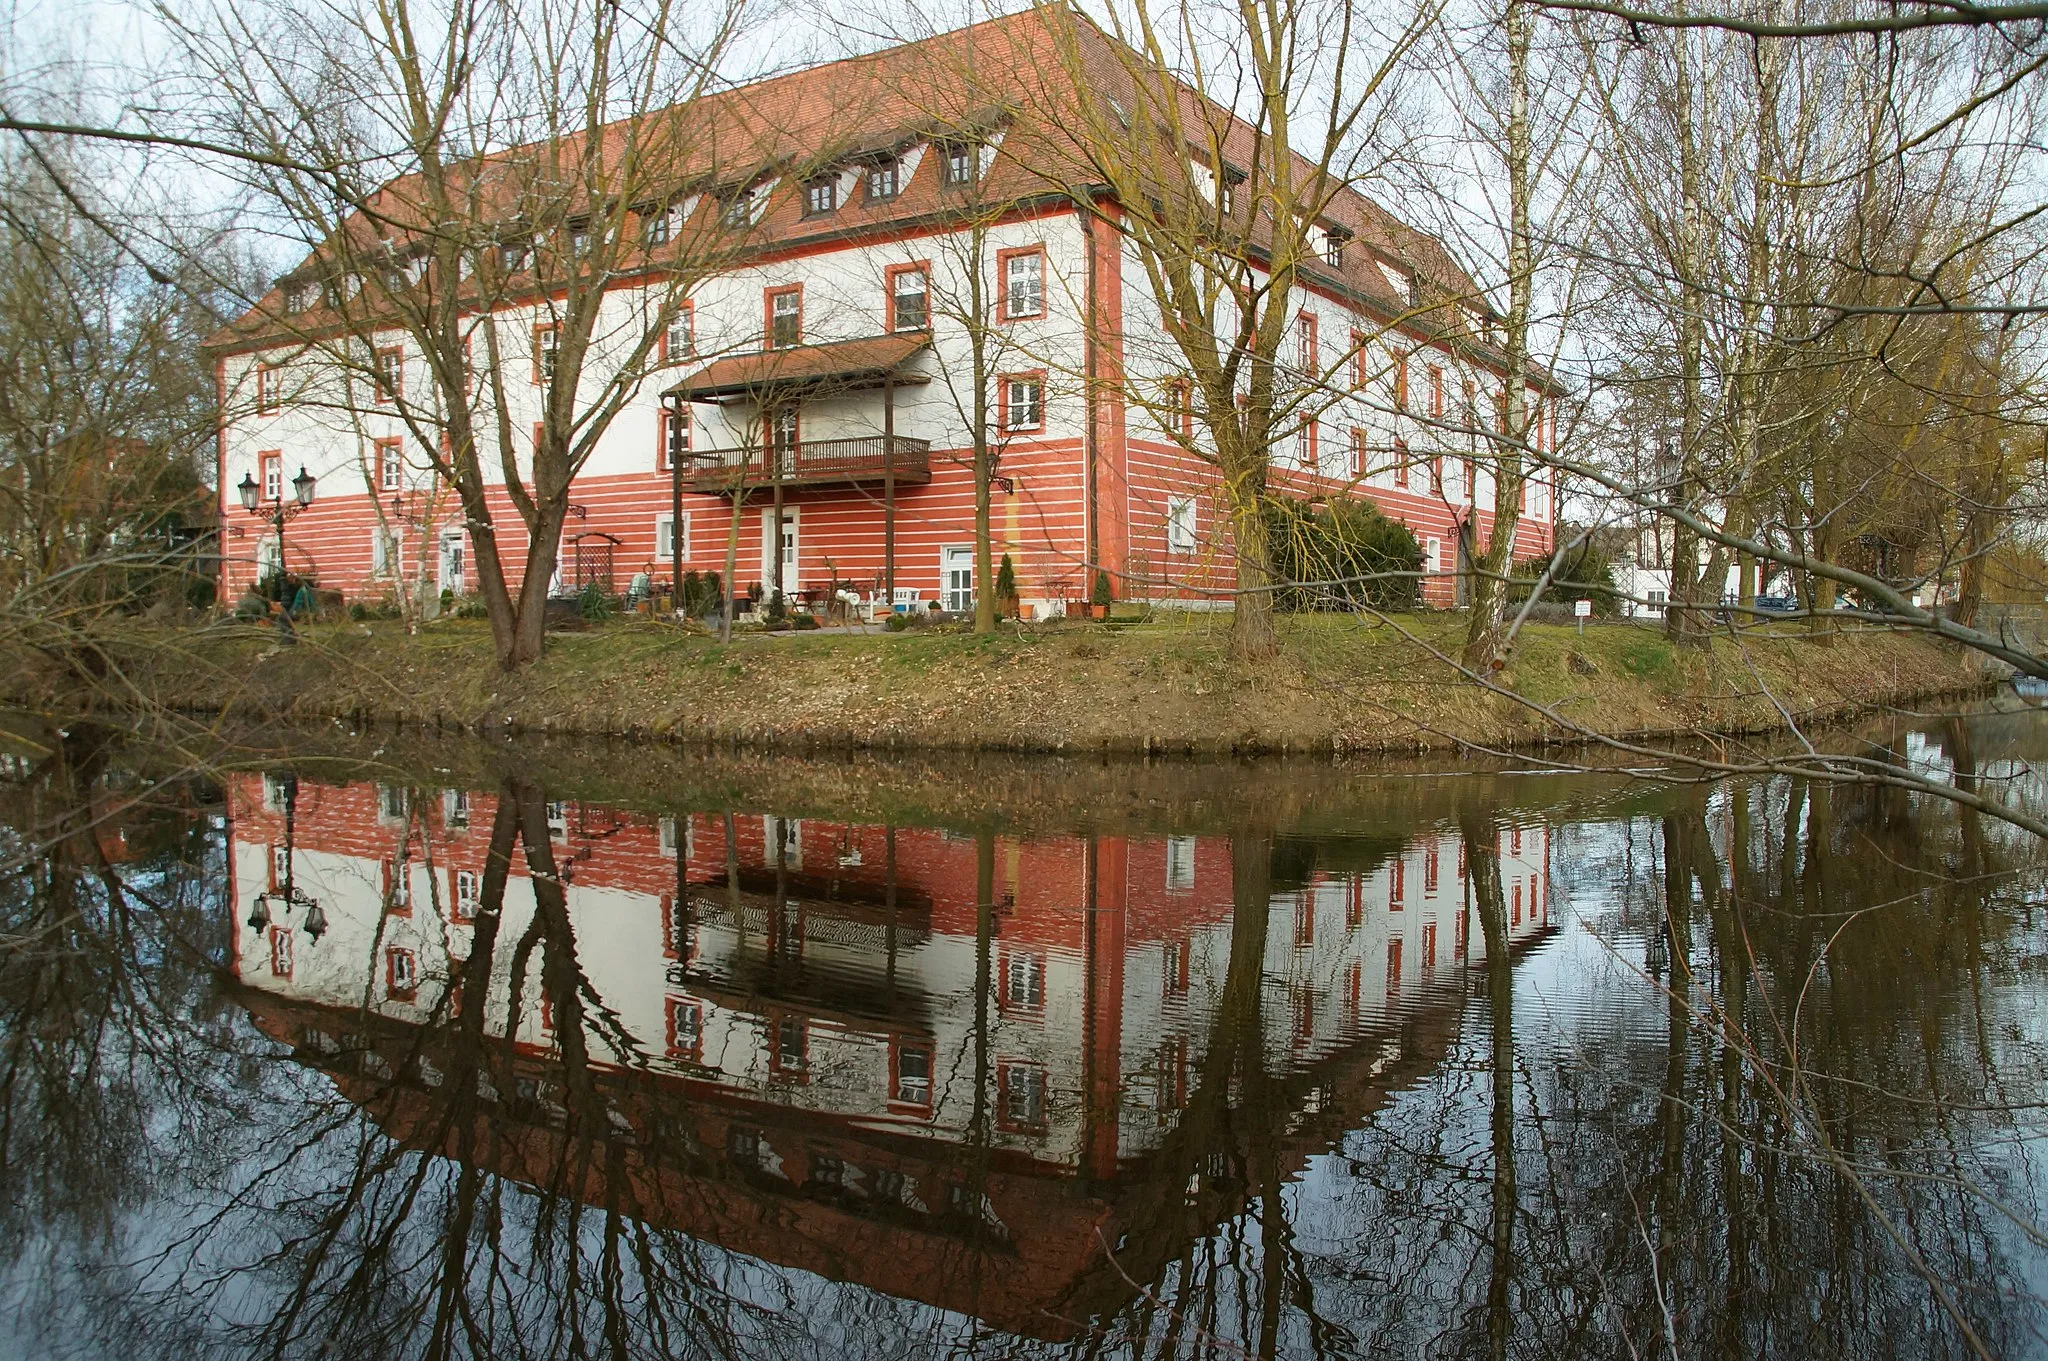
[229,776,1550,1336]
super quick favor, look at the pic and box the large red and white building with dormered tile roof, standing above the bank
[203,6,1554,614]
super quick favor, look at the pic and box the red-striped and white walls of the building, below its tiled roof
[219,11,1554,614]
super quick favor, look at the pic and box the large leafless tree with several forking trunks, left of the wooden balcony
[160,0,770,669]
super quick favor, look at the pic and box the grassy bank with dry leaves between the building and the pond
[72,616,1978,755]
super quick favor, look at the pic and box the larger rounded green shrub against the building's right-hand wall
[1266,497,1421,610]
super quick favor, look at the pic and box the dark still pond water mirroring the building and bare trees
[0,714,2048,1361]
